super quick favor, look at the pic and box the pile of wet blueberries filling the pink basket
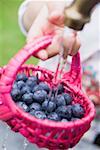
[11,73,85,122]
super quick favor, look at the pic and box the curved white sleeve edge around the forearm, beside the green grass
[18,0,33,36]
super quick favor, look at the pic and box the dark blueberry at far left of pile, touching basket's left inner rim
[11,88,21,102]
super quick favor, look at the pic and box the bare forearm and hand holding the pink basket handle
[23,1,80,60]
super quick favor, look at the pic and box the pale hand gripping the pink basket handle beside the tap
[27,3,80,60]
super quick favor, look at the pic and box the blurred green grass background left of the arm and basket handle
[0,0,37,66]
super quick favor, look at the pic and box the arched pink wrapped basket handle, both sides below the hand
[0,35,80,93]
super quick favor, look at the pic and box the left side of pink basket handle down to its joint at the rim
[0,36,53,121]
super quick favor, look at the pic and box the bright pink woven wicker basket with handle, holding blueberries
[0,36,95,150]
